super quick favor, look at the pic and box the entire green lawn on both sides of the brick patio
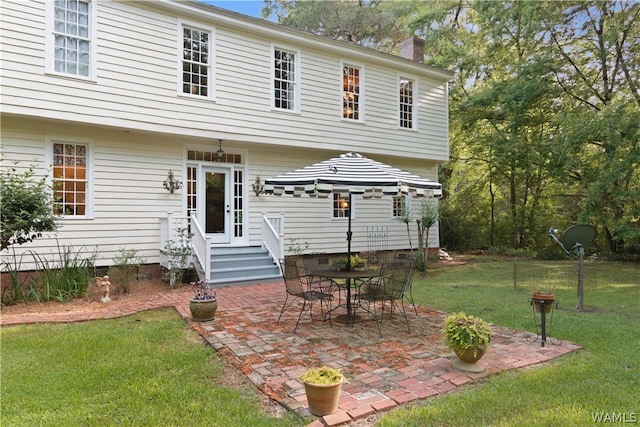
[0,258,640,427]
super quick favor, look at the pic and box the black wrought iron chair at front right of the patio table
[358,262,412,336]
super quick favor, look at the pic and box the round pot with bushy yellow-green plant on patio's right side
[441,312,491,371]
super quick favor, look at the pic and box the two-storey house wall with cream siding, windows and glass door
[0,0,452,284]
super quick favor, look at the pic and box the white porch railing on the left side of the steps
[160,212,211,280]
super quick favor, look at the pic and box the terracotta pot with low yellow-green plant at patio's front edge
[300,366,345,417]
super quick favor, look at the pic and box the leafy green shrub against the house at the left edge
[0,163,58,250]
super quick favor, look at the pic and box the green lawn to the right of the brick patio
[377,260,640,427]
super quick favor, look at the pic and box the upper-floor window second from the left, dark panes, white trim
[182,26,212,98]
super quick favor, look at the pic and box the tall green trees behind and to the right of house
[263,0,640,254]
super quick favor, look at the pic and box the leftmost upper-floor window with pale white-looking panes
[47,0,93,77]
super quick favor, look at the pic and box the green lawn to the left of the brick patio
[0,310,302,427]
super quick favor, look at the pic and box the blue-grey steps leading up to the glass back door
[208,246,282,287]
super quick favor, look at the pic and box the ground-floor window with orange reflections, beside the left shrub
[52,142,89,216]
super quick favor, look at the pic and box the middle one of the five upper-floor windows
[273,48,298,111]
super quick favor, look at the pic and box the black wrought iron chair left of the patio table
[276,259,333,333]
